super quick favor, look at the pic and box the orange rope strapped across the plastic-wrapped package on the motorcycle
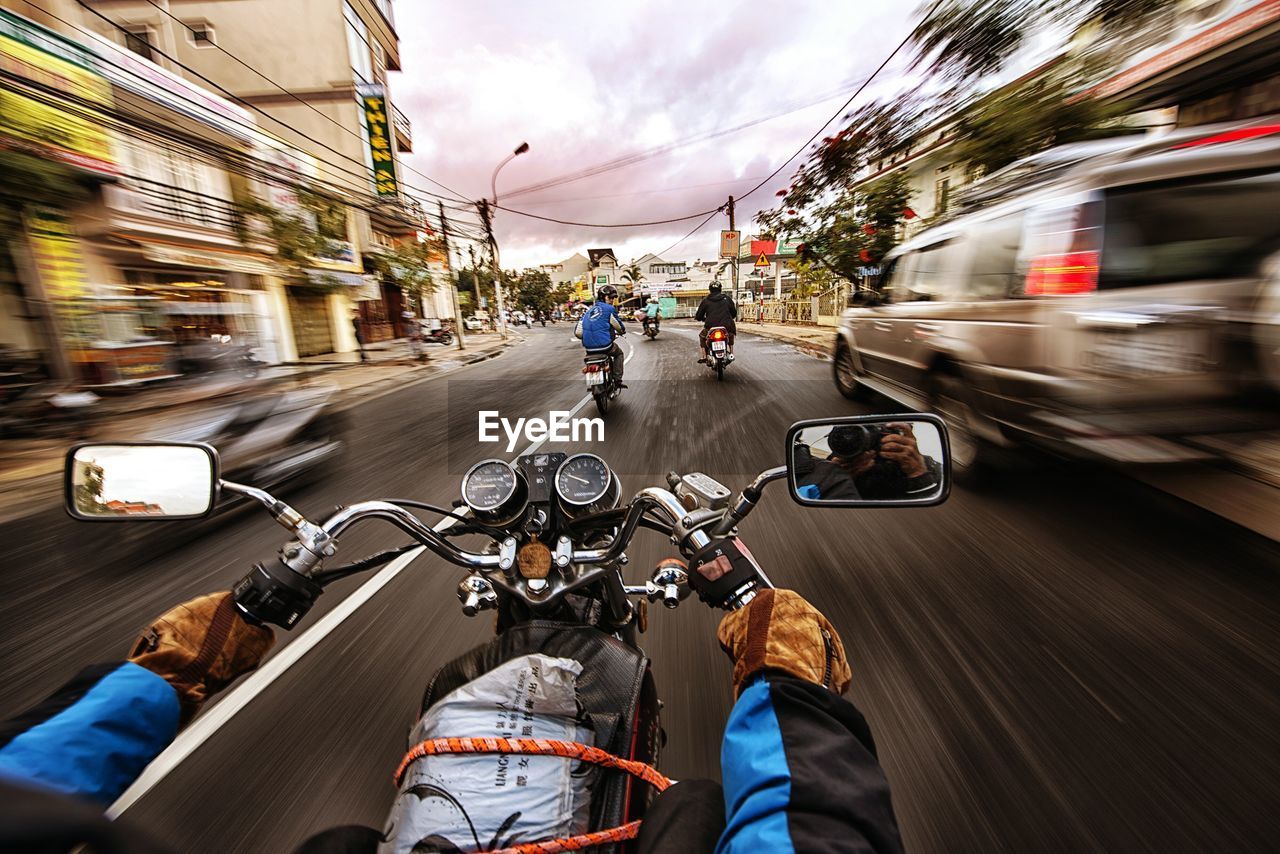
[396,739,671,854]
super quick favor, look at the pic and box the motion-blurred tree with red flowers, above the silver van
[758,0,1174,284]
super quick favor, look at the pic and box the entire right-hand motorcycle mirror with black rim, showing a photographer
[786,412,951,507]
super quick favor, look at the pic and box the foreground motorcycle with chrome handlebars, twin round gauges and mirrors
[65,415,950,851]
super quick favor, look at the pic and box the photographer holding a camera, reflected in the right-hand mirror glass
[794,421,942,501]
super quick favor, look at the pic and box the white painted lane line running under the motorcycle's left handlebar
[106,332,635,818]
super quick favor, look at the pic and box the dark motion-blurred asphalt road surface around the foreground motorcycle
[0,324,1280,851]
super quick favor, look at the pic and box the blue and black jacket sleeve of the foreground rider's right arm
[716,673,902,854]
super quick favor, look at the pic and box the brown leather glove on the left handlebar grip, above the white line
[129,592,275,723]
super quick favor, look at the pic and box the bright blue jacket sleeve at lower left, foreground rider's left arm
[0,662,179,807]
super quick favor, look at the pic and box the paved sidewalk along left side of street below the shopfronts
[0,333,522,521]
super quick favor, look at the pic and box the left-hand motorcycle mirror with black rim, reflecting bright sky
[63,442,219,522]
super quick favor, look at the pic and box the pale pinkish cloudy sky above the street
[392,0,918,268]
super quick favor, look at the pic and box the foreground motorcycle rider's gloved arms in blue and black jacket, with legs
[0,563,901,854]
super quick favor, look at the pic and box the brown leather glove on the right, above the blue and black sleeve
[716,589,852,697]
